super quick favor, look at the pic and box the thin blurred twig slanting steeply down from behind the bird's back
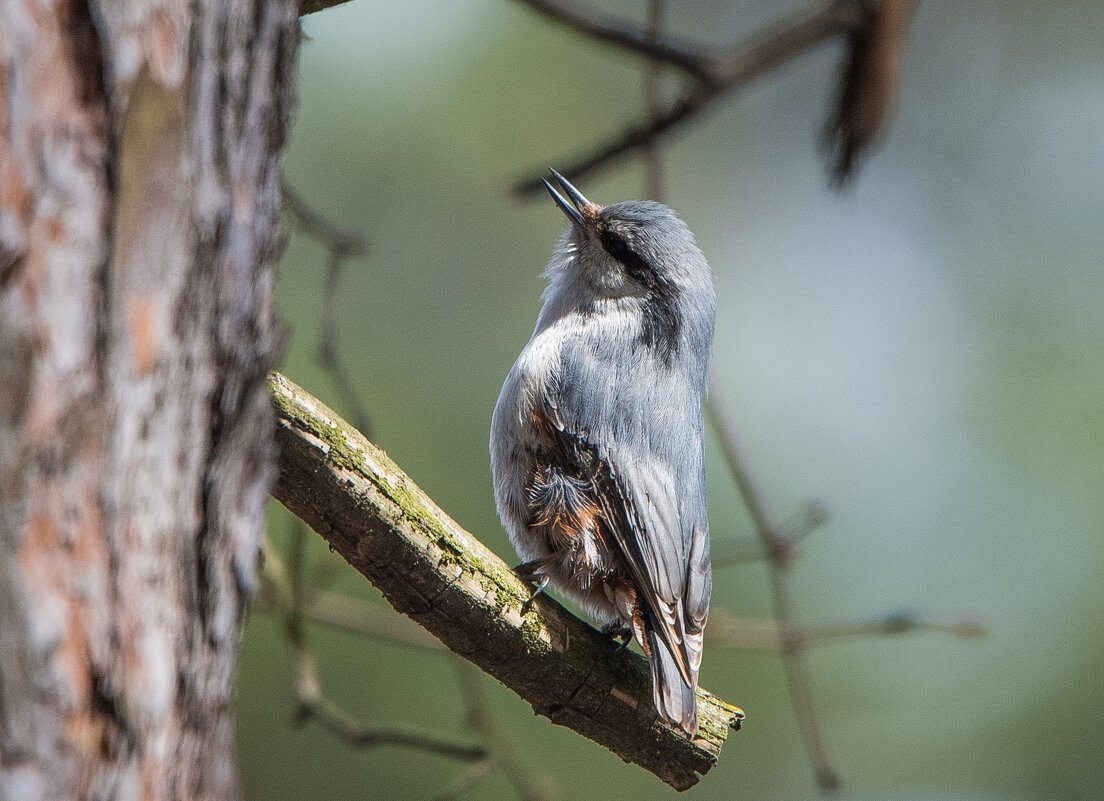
[707,382,841,792]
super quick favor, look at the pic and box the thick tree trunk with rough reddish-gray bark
[0,0,298,801]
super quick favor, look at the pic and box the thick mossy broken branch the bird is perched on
[269,373,743,790]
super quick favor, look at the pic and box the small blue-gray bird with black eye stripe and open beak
[490,170,715,735]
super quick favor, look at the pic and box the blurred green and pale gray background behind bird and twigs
[237,0,1104,801]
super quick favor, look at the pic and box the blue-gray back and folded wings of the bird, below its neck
[546,343,712,687]
